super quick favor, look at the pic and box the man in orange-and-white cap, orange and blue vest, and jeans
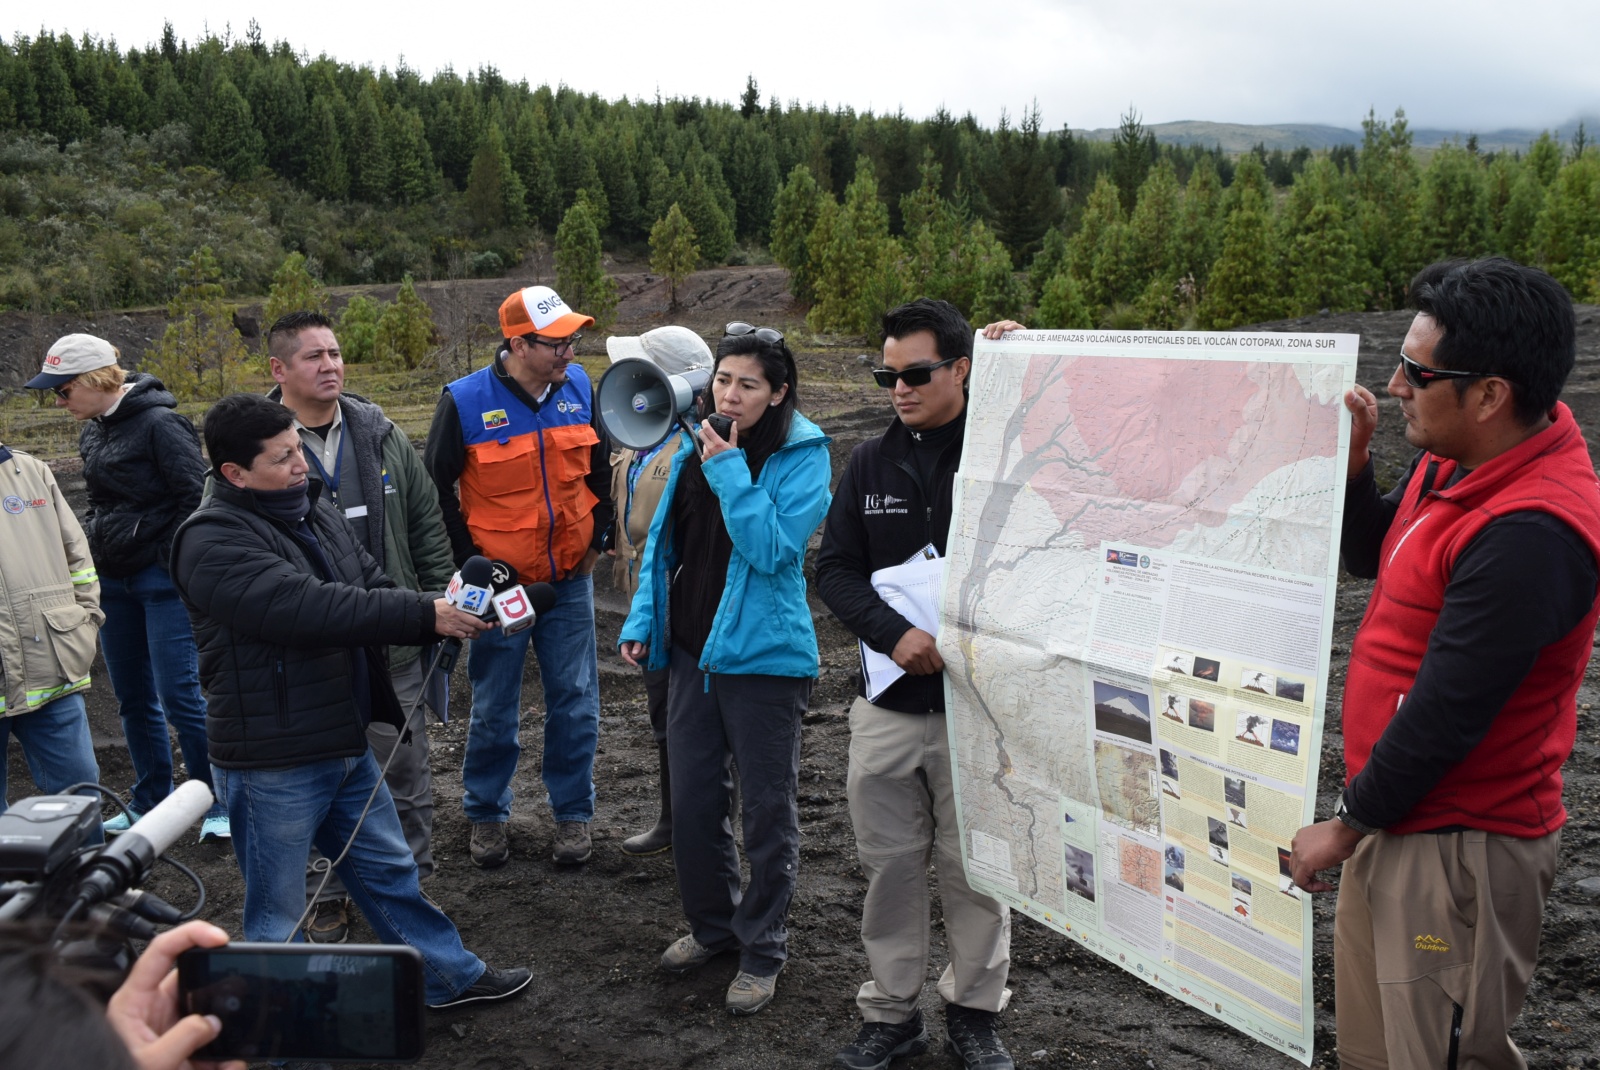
[422,286,611,868]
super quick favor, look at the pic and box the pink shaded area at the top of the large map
[1019,357,1339,547]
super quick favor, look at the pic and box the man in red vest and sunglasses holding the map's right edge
[1290,258,1600,1070]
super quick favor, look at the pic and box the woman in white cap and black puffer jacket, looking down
[51,336,229,843]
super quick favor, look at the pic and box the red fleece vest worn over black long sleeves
[1344,403,1600,838]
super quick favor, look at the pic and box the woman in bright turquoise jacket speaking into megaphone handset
[621,323,830,1014]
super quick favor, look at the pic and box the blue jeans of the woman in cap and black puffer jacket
[101,565,224,817]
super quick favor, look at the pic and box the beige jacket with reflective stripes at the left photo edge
[0,446,106,717]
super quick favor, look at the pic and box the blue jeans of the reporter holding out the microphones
[211,752,483,1003]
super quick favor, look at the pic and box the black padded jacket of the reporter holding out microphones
[171,480,434,769]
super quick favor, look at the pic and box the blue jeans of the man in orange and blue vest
[461,576,600,824]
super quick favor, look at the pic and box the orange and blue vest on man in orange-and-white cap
[446,363,600,584]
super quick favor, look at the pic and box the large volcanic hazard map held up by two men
[939,331,1358,1064]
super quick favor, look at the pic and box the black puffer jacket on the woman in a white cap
[78,371,206,579]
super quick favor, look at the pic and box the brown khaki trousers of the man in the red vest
[1333,832,1562,1070]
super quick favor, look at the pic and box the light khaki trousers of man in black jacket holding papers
[846,697,1011,1022]
